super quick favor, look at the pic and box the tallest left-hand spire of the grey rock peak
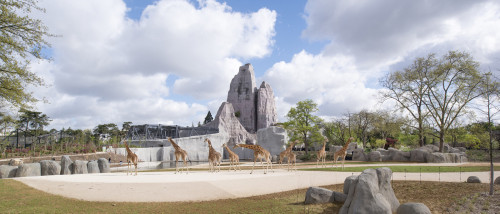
[227,64,257,132]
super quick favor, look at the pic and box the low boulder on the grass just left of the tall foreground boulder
[304,187,347,204]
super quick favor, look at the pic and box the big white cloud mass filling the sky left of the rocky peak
[33,0,276,128]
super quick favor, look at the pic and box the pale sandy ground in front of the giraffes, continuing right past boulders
[13,164,500,202]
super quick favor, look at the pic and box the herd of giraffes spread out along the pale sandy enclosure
[124,137,354,175]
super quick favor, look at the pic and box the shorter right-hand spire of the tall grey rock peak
[257,82,278,130]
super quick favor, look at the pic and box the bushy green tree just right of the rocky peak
[283,99,323,154]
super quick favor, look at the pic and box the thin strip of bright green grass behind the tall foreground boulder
[299,166,500,172]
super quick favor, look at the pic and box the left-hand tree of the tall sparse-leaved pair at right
[380,54,437,146]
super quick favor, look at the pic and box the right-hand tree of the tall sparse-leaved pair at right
[424,51,483,152]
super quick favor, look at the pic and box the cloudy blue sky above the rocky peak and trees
[25,0,500,129]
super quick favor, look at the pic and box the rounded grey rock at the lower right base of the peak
[257,126,288,155]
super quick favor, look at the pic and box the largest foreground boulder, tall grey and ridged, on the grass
[339,168,399,214]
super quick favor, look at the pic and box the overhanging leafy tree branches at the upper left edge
[0,0,54,108]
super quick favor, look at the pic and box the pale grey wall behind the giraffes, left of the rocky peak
[111,133,229,162]
